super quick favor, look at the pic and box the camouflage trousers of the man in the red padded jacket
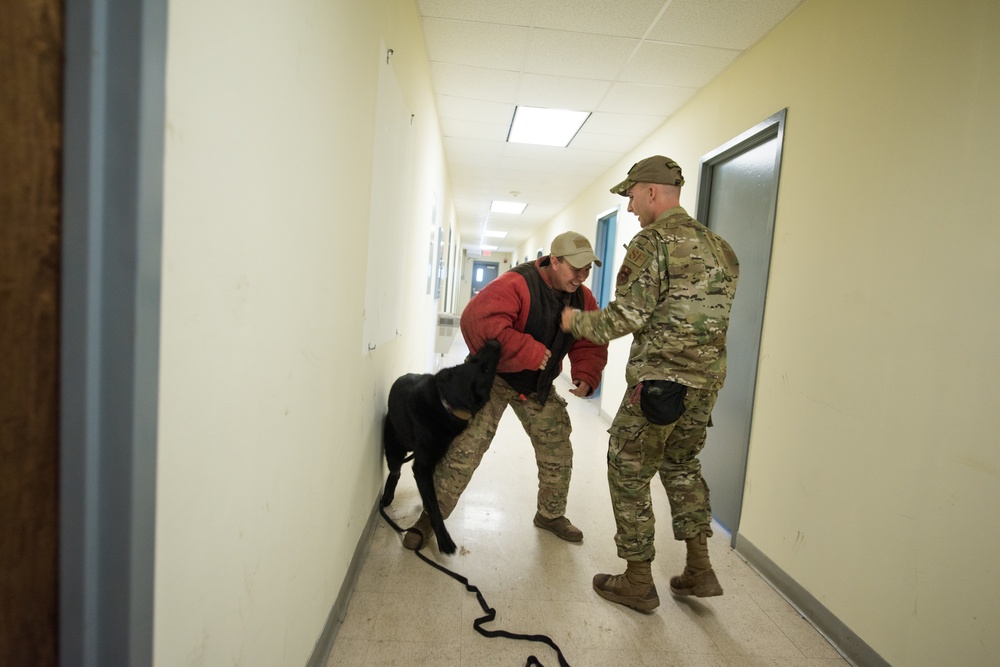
[434,377,573,519]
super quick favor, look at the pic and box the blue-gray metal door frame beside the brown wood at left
[59,0,168,667]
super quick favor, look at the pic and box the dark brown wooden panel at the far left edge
[0,0,63,667]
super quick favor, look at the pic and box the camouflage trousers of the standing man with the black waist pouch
[608,380,718,561]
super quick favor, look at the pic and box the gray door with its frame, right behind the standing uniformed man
[698,111,785,542]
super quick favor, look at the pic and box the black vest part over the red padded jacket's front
[497,262,583,405]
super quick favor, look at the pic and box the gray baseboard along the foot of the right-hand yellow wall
[733,534,891,667]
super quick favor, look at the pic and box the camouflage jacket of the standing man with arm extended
[572,207,739,389]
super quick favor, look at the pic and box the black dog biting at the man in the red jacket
[381,340,500,554]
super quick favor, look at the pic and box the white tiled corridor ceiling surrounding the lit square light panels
[418,0,802,252]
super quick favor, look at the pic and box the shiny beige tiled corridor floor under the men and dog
[327,343,848,667]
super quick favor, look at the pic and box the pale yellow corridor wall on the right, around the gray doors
[522,0,1000,666]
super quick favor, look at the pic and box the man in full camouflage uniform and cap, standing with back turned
[562,155,739,611]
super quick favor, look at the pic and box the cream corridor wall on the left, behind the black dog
[154,0,453,667]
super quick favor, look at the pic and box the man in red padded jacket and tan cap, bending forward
[403,232,608,549]
